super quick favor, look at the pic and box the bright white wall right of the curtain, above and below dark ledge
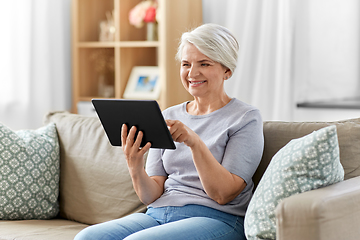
[294,0,360,121]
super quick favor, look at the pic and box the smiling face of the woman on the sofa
[180,43,231,98]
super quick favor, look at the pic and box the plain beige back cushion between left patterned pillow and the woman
[45,112,145,224]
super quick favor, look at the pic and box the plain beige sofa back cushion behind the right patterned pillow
[253,118,360,186]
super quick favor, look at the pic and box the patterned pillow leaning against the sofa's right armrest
[244,126,344,240]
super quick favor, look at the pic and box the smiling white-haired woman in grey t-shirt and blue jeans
[75,24,264,240]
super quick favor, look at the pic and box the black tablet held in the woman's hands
[92,99,175,149]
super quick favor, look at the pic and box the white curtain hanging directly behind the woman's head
[203,0,295,121]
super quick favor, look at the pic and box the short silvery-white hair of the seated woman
[176,23,239,74]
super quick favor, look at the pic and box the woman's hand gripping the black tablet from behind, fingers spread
[121,124,151,174]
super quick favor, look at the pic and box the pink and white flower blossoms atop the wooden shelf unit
[129,0,158,28]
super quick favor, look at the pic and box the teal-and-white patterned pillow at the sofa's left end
[0,123,60,220]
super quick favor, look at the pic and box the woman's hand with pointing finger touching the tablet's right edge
[166,120,201,147]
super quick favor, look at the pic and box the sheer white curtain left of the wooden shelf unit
[0,0,71,130]
